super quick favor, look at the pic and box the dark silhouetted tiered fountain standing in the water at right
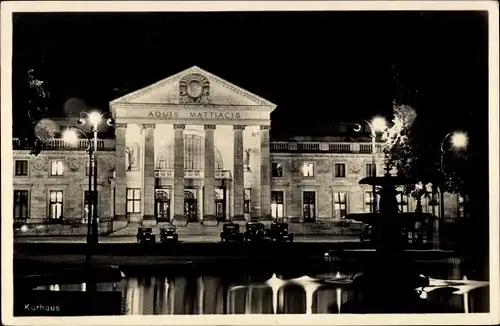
[340,174,438,312]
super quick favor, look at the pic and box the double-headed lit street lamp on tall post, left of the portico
[77,111,114,244]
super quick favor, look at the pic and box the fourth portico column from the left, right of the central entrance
[203,125,216,224]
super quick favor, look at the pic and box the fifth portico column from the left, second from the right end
[233,125,245,220]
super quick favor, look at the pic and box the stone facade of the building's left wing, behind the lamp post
[13,148,115,223]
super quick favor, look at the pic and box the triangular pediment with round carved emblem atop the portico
[111,66,276,110]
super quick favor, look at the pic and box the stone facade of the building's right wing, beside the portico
[271,148,461,221]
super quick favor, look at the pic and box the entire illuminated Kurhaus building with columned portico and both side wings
[14,67,463,232]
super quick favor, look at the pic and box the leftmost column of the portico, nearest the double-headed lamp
[115,123,127,219]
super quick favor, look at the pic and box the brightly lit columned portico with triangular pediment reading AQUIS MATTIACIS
[110,67,276,225]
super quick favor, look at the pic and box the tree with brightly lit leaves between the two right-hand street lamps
[380,103,470,211]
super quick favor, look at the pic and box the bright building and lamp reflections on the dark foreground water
[34,262,489,315]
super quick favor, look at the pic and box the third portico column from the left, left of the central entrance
[173,125,185,221]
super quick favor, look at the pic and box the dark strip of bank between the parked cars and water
[14,242,457,264]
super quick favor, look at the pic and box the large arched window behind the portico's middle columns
[156,134,223,170]
